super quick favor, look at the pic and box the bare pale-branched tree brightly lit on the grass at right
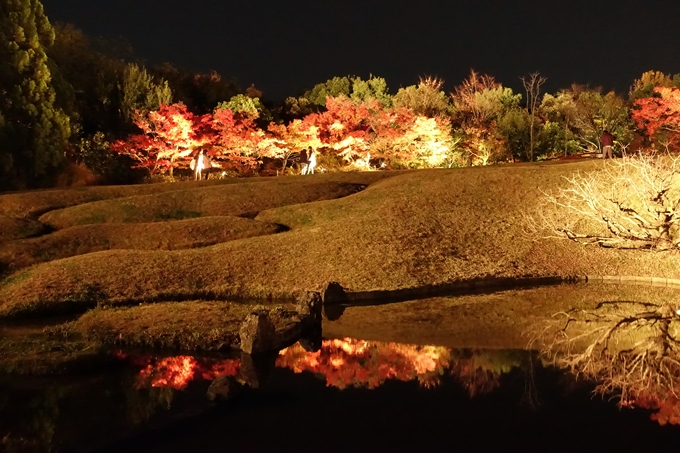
[528,155,680,250]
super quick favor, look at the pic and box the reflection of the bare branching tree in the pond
[532,301,680,422]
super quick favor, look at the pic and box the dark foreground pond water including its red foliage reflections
[0,338,680,453]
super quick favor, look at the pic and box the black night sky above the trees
[43,0,680,100]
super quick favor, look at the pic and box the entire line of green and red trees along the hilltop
[0,0,680,190]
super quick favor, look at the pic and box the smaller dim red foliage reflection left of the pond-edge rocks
[116,353,241,390]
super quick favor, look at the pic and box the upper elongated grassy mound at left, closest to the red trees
[39,178,372,229]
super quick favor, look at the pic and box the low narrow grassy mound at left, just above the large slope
[0,216,283,272]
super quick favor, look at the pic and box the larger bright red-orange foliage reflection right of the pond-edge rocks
[276,338,451,388]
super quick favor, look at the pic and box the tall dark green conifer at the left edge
[0,0,70,189]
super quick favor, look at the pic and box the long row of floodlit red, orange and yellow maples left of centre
[112,92,452,173]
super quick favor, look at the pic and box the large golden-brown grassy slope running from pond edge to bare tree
[0,162,680,314]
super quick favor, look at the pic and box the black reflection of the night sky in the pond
[101,362,680,453]
